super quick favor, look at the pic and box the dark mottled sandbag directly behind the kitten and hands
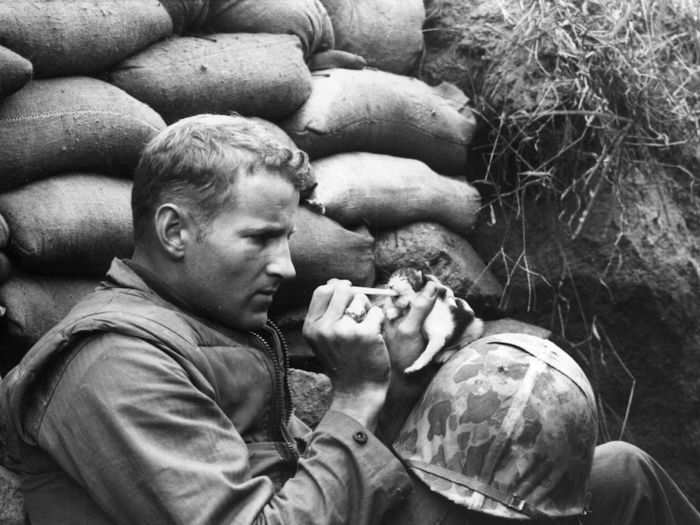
[374,222,503,308]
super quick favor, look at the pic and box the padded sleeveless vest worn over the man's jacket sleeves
[0,283,308,485]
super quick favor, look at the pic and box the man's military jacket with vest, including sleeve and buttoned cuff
[0,260,410,525]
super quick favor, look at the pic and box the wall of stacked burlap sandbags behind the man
[0,0,500,361]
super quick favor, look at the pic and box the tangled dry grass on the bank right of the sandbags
[438,0,700,229]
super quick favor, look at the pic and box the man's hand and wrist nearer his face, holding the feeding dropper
[303,279,391,430]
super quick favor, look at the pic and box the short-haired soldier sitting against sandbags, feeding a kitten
[0,115,700,525]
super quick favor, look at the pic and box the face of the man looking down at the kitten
[185,169,299,330]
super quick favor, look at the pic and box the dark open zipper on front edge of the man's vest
[251,321,299,460]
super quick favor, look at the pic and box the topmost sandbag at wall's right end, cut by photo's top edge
[321,0,425,73]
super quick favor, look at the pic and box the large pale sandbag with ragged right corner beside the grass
[281,69,476,175]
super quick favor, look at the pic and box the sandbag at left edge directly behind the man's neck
[0,174,133,276]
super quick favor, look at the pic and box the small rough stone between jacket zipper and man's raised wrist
[288,368,332,428]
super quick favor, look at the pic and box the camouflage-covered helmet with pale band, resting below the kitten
[394,334,598,520]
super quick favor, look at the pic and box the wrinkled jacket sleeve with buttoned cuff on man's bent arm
[38,334,410,525]
